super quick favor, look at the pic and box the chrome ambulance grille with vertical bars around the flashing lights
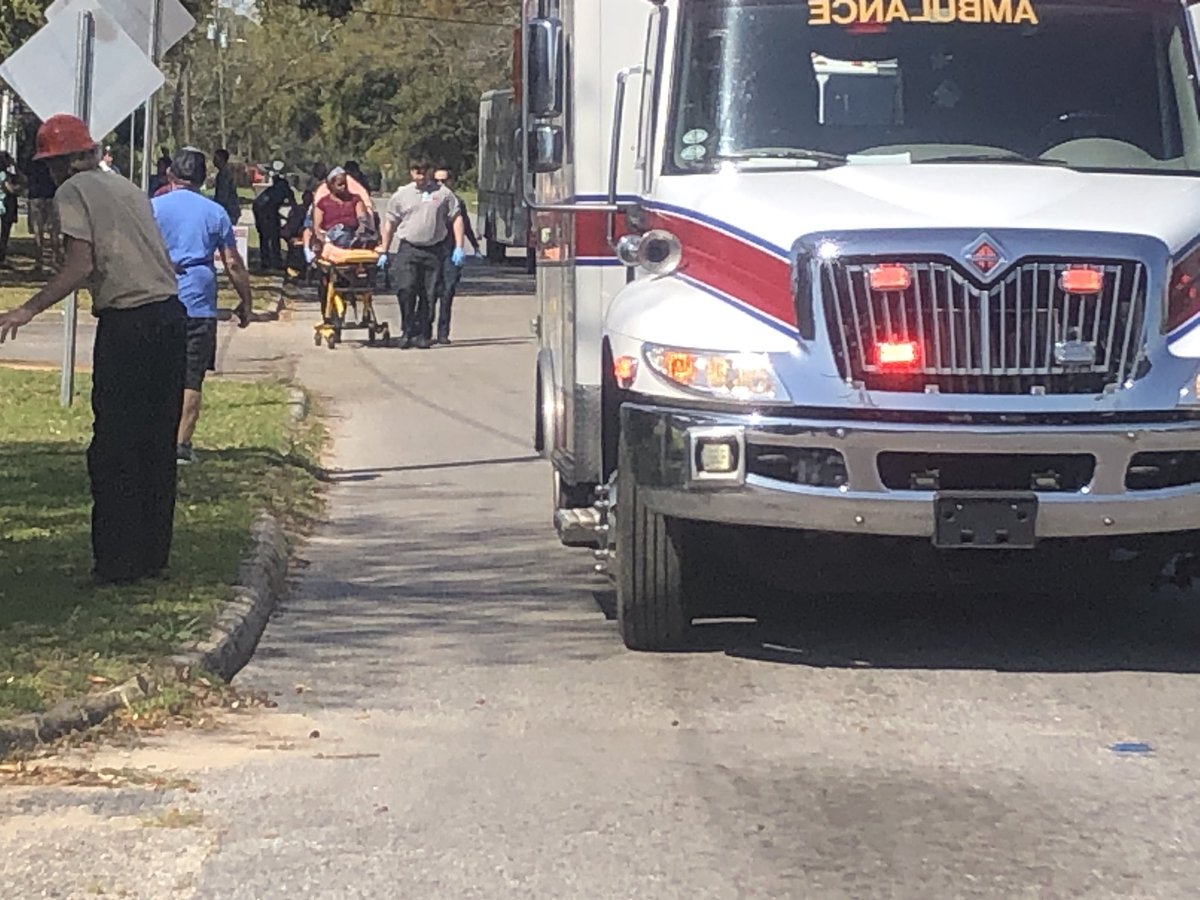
[821,258,1146,394]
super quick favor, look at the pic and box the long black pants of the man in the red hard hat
[88,298,187,581]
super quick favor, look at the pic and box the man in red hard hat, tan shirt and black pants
[0,115,187,583]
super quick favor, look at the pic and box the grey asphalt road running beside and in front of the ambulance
[0,259,1200,900]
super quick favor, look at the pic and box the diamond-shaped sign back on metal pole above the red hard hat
[0,0,164,139]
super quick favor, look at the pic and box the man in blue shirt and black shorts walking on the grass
[151,148,251,463]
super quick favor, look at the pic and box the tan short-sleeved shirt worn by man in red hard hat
[54,169,179,313]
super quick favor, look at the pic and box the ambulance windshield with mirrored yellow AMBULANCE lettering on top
[667,0,1200,174]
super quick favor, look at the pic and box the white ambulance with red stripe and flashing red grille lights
[517,0,1200,650]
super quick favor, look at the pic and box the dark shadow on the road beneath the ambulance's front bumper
[681,588,1200,673]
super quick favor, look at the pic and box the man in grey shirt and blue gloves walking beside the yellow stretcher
[379,157,467,349]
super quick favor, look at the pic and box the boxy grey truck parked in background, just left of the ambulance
[475,89,536,271]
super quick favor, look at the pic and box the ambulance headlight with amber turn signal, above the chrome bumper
[644,344,790,402]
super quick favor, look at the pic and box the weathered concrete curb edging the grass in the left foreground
[0,512,288,758]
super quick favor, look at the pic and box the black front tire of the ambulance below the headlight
[616,437,691,650]
